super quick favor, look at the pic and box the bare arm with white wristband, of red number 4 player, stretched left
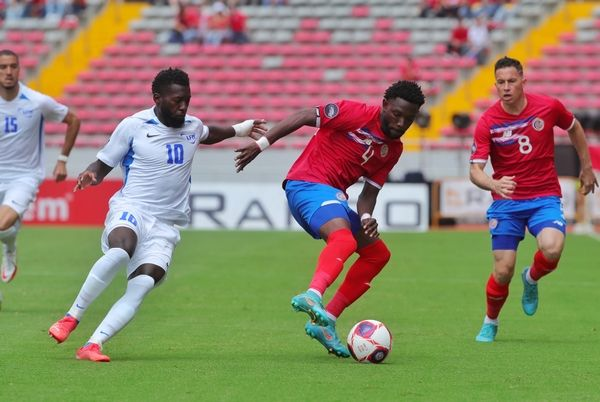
[235,108,317,172]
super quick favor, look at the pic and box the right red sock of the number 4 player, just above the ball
[326,240,391,317]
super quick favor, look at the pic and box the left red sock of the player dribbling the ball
[309,229,356,294]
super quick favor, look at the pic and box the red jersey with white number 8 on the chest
[471,94,575,200]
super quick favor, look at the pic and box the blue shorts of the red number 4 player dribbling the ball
[285,180,360,239]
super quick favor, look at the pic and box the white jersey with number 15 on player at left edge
[0,83,69,180]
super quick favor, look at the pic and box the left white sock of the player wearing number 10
[68,248,129,320]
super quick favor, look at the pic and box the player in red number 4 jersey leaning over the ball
[236,81,425,357]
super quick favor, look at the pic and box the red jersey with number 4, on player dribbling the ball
[286,100,403,192]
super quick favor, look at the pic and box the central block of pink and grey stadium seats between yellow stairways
[43,0,488,147]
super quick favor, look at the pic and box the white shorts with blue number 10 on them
[102,203,180,276]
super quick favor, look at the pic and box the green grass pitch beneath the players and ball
[0,227,600,401]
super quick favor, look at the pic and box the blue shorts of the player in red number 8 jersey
[487,196,567,250]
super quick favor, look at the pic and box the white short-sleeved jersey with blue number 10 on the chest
[97,108,208,225]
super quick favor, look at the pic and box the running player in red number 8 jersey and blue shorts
[470,57,598,342]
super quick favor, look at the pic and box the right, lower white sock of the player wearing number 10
[88,275,154,345]
